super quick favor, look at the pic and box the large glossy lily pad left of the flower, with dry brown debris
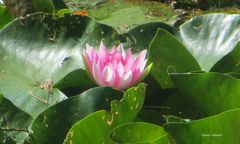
[0,13,124,117]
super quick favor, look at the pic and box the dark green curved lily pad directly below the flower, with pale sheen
[29,87,122,144]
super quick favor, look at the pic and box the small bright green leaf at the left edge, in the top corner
[0,5,12,29]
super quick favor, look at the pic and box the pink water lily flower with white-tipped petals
[83,42,151,90]
